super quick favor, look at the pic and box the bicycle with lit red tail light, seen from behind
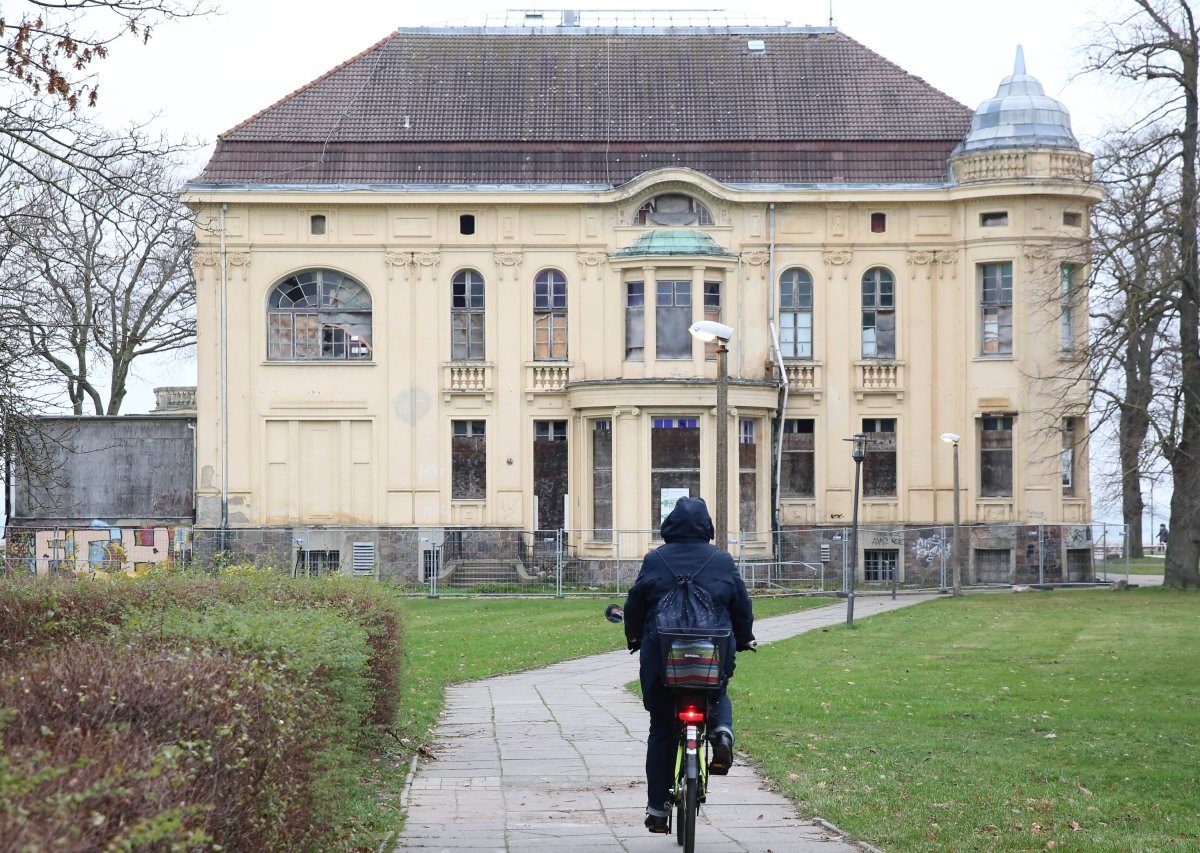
[605,605,757,853]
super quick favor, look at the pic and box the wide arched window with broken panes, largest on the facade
[266,270,372,361]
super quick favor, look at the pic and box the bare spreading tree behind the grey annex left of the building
[0,155,196,415]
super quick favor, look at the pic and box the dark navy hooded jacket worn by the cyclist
[625,498,754,692]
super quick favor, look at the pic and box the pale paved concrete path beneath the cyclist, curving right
[400,595,937,853]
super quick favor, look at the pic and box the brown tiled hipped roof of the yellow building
[197,28,971,185]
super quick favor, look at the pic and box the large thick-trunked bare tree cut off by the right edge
[1091,0,1200,587]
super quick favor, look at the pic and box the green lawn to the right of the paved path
[731,589,1200,852]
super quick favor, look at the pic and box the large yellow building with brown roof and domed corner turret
[186,13,1098,579]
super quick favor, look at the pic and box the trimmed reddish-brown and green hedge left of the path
[0,575,402,851]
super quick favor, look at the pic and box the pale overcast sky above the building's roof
[77,0,1152,532]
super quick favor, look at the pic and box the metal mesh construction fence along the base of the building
[6,524,1128,596]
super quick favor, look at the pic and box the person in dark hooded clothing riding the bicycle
[625,498,754,833]
